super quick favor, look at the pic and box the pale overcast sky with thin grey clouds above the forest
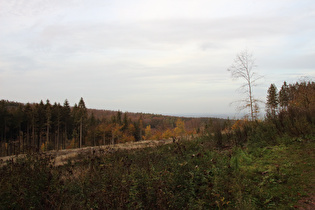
[0,0,315,117]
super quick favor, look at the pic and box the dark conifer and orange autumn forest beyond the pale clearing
[0,98,226,156]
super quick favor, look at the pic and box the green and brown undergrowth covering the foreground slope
[0,136,315,209]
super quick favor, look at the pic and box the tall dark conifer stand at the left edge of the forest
[0,98,88,155]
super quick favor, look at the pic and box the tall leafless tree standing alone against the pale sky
[227,50,262,120]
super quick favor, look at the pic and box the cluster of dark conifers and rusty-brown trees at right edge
[266,81,315,136]
